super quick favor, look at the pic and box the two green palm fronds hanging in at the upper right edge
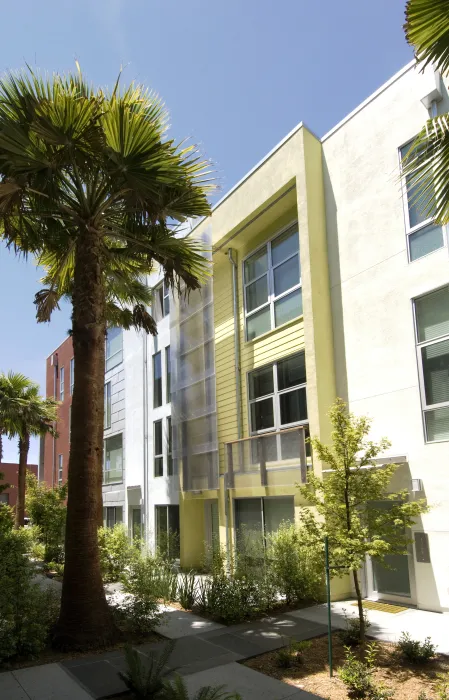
[403,0,449,224]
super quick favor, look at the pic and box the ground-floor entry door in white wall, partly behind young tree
[367,501,413,602]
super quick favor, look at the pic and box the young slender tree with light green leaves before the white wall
[300,399,427,643]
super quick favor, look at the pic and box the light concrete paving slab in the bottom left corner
[11,664,92,700]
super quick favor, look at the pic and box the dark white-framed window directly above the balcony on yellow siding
[248,351,307,434]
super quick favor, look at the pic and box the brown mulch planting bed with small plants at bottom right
[245,633,449,700]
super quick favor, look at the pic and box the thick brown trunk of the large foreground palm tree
[53,227,118,650]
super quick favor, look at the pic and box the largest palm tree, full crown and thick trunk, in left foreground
[0,72,211,648]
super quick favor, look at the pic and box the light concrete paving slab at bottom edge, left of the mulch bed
[178,663,307,700]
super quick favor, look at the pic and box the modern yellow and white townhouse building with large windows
[43,62,449,611]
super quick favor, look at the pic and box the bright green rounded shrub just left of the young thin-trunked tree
[267,523,324,605]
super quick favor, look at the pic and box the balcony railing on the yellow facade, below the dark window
[225,426,307,488]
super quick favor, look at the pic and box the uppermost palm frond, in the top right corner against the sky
[404,0,449,73]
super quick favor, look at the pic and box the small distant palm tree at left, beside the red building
[9,383,58,529]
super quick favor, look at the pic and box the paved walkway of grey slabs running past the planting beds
[0,601,449,700]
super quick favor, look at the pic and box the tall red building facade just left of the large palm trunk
[40,336,74,486]
